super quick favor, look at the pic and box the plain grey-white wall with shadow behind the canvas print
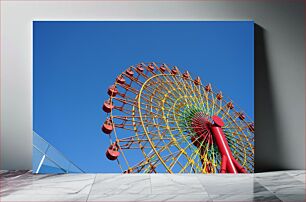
[0,0,305,171]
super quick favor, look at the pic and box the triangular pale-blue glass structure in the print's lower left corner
[32,132,84,173]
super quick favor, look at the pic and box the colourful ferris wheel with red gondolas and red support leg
[102,62,254,173]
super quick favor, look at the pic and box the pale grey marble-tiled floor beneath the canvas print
[0,170,306,202]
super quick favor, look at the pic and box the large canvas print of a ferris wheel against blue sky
[33,21,255,174]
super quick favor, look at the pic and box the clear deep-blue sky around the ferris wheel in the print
[33,21,254,172]
